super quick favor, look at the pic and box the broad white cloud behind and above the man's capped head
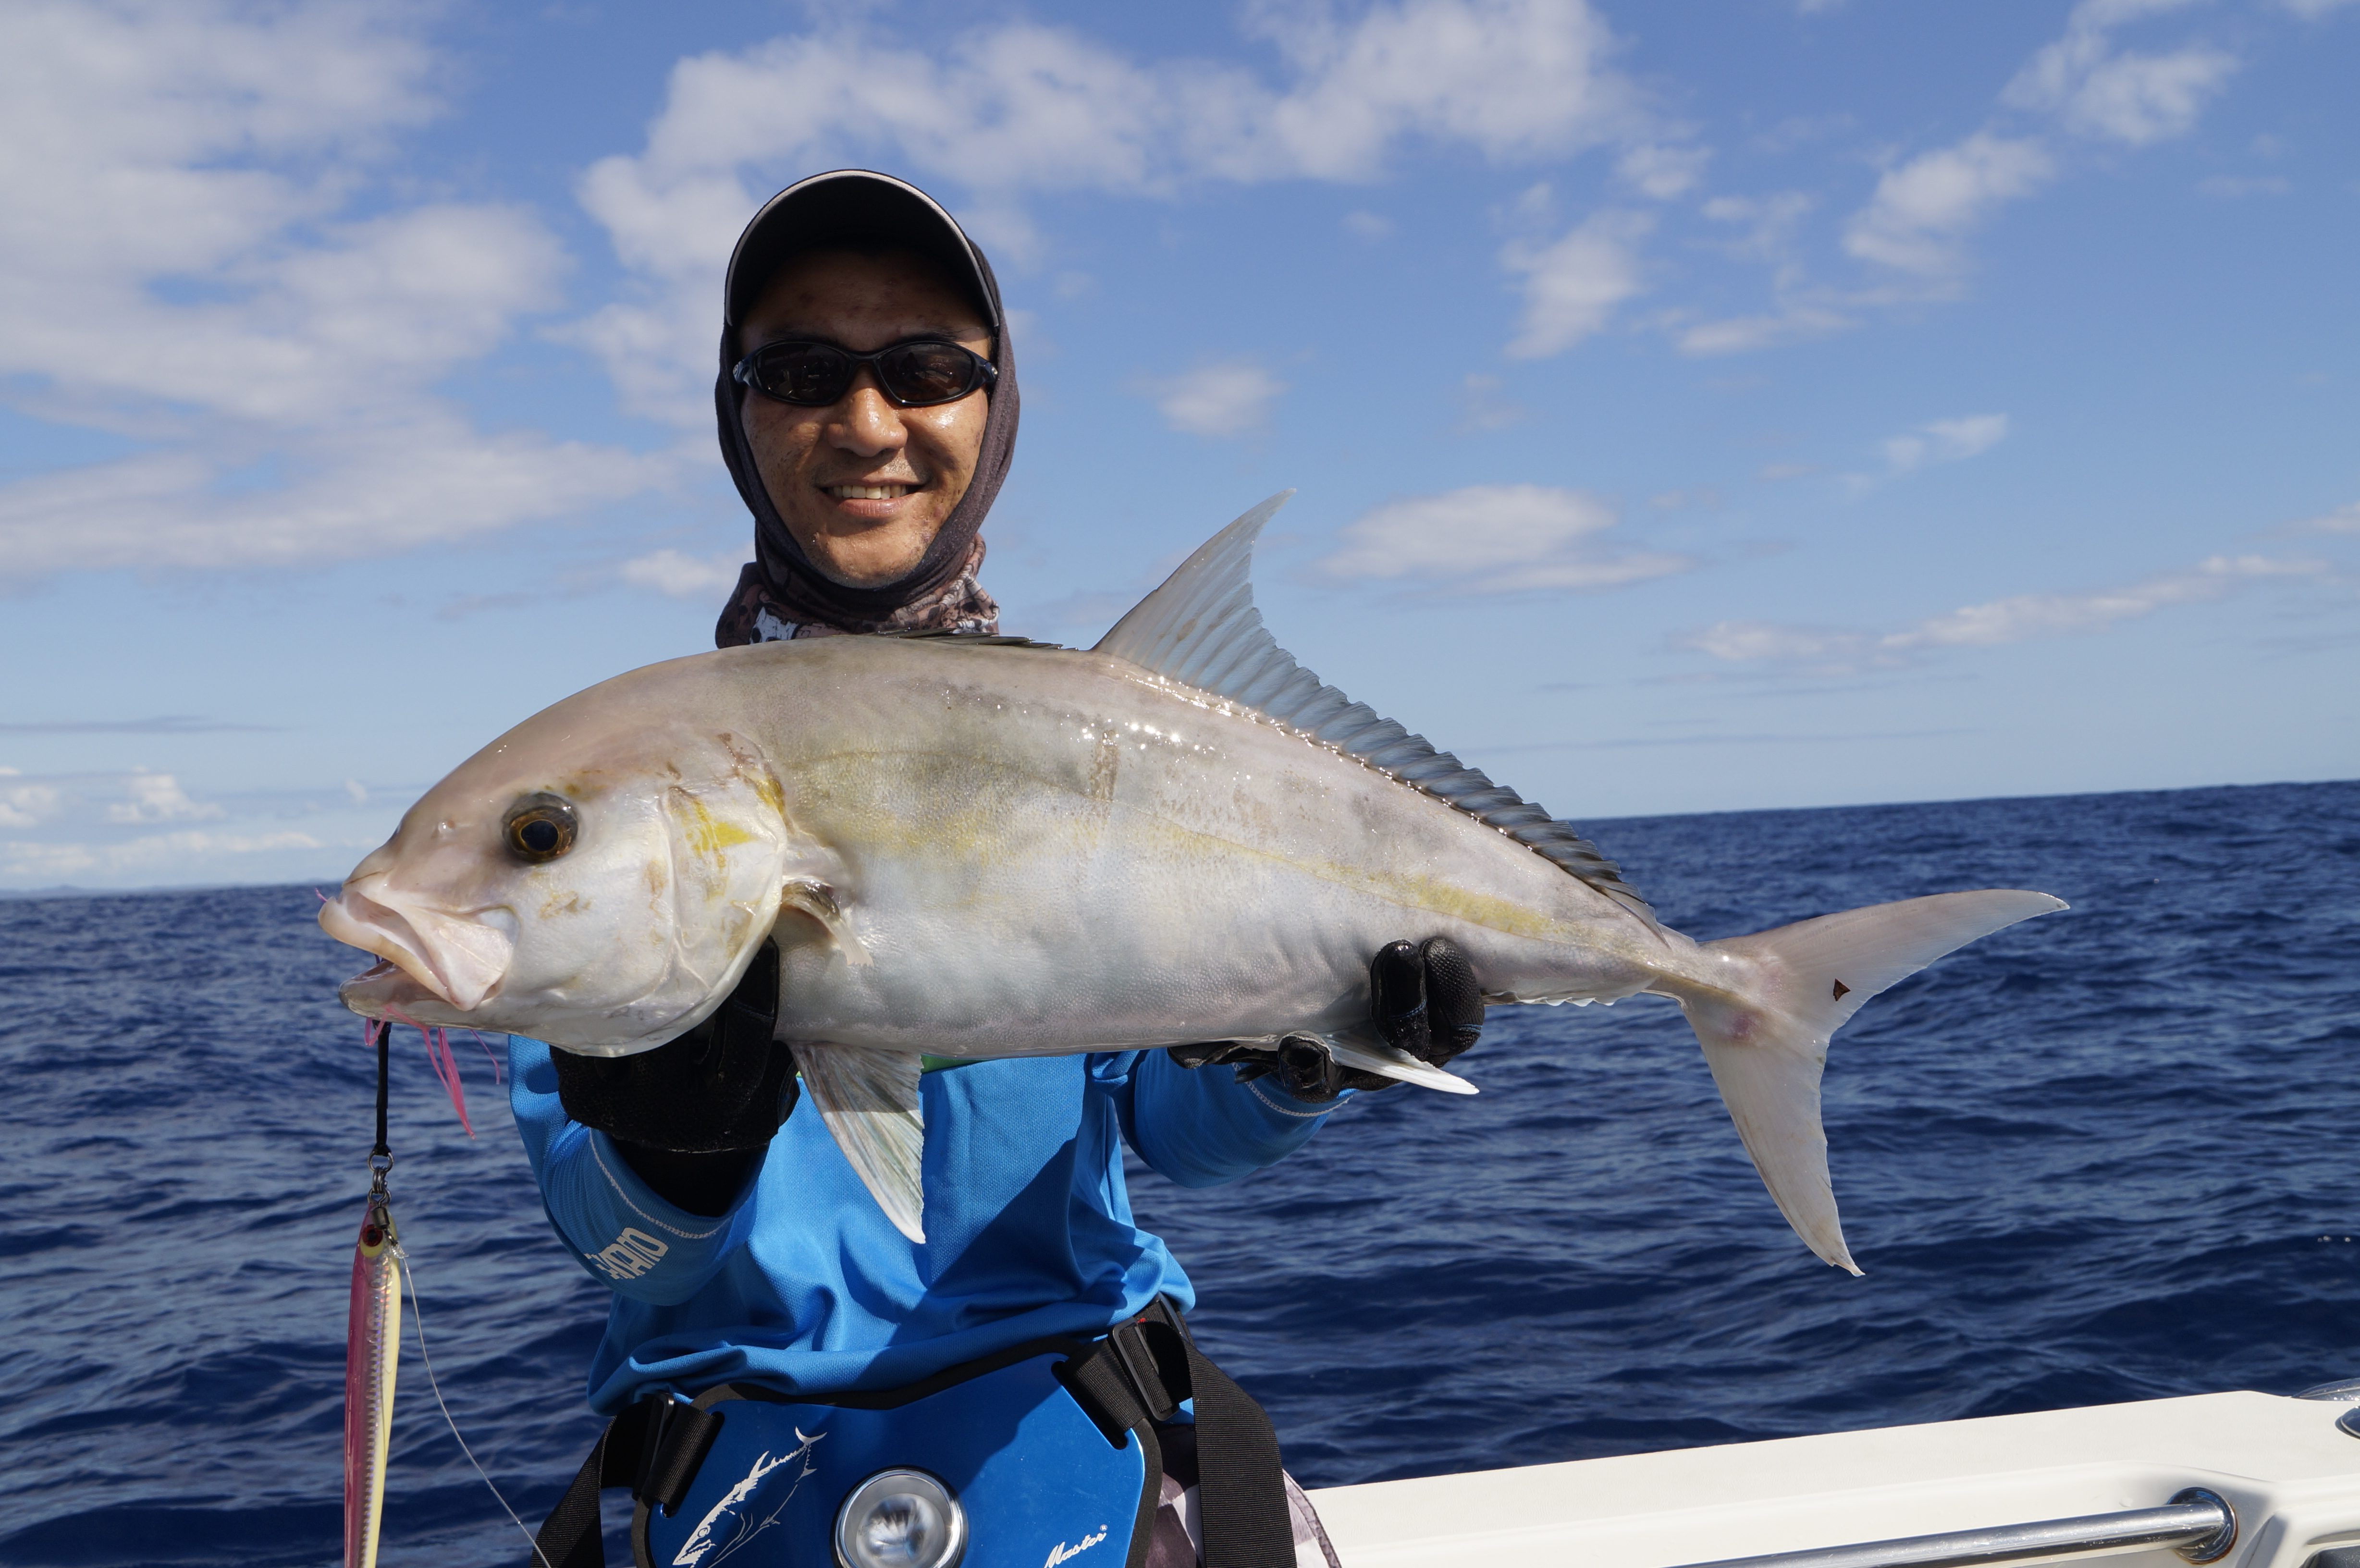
[578,0,1643,425]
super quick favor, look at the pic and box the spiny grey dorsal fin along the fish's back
[1090,491,1654,926]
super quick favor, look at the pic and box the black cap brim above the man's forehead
[722,168,1001,335]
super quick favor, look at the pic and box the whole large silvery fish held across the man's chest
[319,496,2063,1273]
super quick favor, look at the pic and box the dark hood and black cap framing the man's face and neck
[713,170,1017,647]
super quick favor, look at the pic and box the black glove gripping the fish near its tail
[1170,938,1482,1105]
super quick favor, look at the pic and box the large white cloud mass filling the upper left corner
[0,0,654,576]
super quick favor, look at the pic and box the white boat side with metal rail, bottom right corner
[1312,1379,2360,1568]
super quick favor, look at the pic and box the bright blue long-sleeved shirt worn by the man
[507,1037,1348,1412]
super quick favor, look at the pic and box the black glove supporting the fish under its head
[550,942,795,1214]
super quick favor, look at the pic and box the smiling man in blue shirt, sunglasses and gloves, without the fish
[512,172,1482,1556]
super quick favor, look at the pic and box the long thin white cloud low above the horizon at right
[1673,555,2327,671]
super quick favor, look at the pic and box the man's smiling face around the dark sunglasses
[738,250,991,588]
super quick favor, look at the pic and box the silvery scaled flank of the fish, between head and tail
[694,637,1661,1055]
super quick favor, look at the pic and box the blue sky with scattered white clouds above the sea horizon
[0,0,2360,888]
